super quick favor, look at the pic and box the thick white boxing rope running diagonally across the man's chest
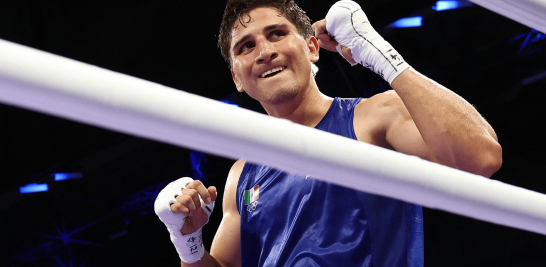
[0,40,546,235]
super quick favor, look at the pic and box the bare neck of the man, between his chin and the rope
[262,80,333,127]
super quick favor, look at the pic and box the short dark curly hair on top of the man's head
[218,0,314,69]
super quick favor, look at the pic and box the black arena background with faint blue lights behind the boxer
[0,0,546,266]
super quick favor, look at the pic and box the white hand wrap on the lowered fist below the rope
[154,177,214,263]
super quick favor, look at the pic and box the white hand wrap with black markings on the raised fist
[326,0,410,84]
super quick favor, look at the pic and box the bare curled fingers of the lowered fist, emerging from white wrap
[171,181,218,235]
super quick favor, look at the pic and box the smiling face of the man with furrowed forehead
[230,8,318,105]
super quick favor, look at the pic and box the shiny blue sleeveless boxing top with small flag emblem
[237,98,424,267]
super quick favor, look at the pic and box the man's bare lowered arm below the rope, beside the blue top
[181,160,245,267]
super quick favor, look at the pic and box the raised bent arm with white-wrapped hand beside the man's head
[313,0,502,177]
